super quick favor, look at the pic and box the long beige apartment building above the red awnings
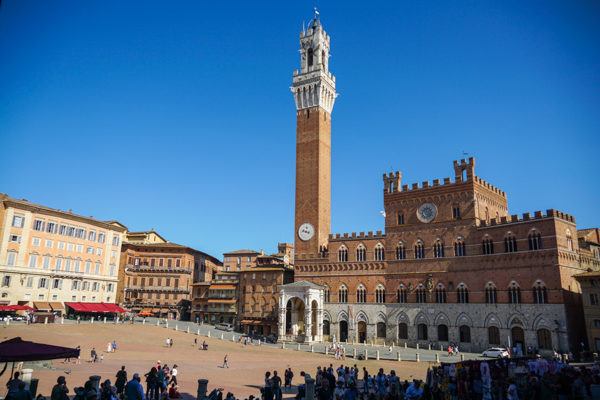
[0,194,127,313]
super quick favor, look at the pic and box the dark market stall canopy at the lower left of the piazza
[0,337,79,362]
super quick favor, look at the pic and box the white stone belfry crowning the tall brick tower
[290,17,337,114]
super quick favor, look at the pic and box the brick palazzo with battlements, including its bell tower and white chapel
[279,18,600,352]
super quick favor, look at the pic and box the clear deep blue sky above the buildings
[0,0,600,257]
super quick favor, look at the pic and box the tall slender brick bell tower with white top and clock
[291,14,337,260]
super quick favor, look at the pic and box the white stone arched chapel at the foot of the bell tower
[278,281,324,343]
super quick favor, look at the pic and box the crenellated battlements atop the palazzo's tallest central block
[383,157,506,198]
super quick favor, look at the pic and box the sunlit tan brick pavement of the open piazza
[7,322,429,398]
